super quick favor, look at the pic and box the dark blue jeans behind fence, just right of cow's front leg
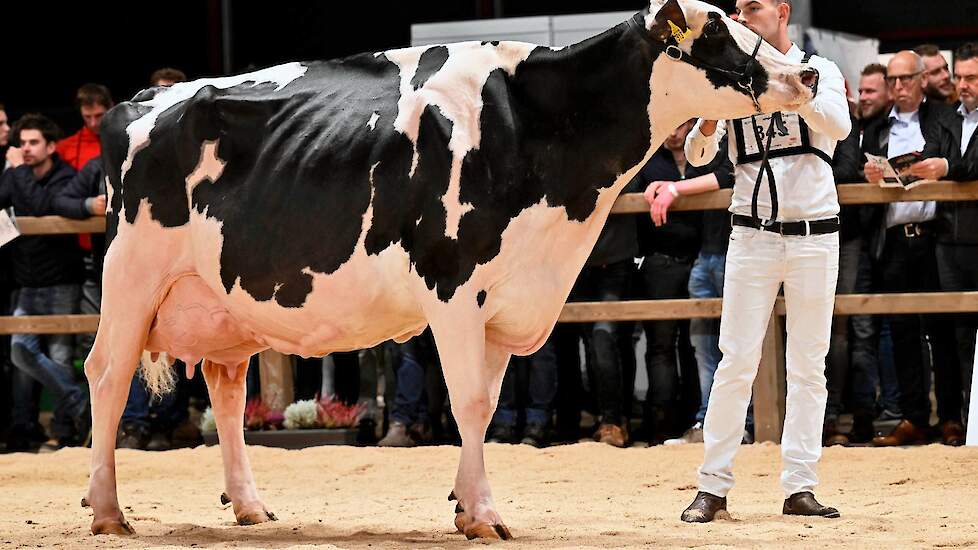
[492,335,557,426]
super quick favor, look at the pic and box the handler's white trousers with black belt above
[699,227,839,498]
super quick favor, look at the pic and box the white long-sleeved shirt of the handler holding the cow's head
[686,45,852,221]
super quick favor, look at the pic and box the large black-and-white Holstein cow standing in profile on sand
[85,0,817,538]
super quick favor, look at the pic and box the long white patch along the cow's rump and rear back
[121,63,307,187]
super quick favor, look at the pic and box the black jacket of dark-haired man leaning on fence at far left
[0,154,85,287]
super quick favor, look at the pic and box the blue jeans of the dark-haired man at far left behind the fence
[10,285,87,434]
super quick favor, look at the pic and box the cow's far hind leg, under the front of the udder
[201,359,276,525]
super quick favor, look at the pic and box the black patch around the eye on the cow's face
[690,12,769,101]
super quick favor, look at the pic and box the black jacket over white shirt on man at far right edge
[924,104,978,245]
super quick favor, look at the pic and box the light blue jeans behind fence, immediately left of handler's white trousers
[689,253,727,422]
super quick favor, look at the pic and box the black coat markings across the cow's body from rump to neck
[106,18,657,307]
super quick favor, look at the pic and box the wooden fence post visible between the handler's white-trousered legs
[754,312,787,443]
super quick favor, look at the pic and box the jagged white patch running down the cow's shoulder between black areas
[386,41,539,239]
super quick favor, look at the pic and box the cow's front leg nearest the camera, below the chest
[432,318,512,540]
